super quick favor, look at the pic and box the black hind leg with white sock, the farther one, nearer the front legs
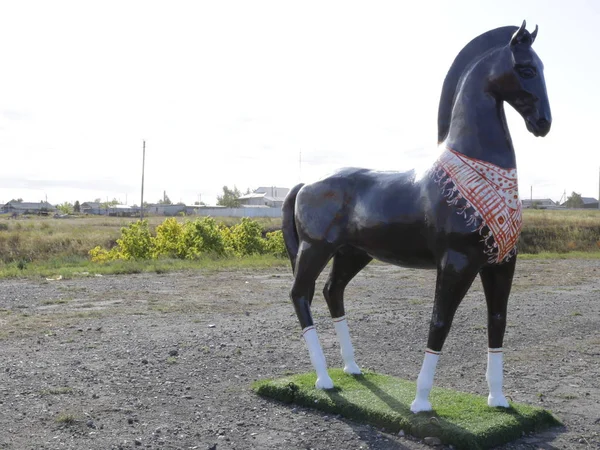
[323,248,373,375]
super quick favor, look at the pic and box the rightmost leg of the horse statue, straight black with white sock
[479,258,516,408]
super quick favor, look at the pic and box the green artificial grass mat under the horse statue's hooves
[252,369,561,449]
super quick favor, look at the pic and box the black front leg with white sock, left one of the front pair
[410,250,479,413]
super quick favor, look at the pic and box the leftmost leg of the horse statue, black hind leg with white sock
[290,241,333,389]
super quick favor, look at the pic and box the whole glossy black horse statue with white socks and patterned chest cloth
[282,22,552,412]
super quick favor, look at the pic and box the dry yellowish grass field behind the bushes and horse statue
[0,210,600,269]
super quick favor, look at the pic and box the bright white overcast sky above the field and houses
[0,0,600,204]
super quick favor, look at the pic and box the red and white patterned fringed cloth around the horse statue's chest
[431,148,522,264]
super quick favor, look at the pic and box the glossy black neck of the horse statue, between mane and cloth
[445,62,516,169]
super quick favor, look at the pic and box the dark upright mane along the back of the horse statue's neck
[438,26,519,143]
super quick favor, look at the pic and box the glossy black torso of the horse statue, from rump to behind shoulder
[295,168,433,266]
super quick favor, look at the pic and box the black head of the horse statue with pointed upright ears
[490,21,552,136]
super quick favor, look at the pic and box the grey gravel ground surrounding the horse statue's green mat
[0,260,600,450]
